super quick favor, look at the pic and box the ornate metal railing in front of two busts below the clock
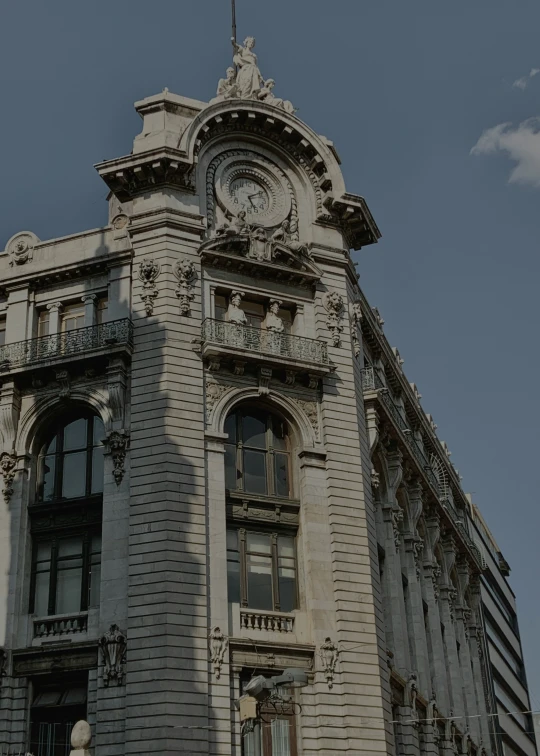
[202,318,330,365]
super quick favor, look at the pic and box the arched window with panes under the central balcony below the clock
[225,407,291,497]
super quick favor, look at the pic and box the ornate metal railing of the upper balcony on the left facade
[0,318,133,372]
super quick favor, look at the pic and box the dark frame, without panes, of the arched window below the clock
[225,405,294,499]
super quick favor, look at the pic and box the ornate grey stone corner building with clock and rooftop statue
[0,39,536,756]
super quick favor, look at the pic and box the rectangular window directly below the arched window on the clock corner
[227,528,297,612]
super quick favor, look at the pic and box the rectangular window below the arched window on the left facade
[30,532,101,616]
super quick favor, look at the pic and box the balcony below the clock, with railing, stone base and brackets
[201,318,334,385]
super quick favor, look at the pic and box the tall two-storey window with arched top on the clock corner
[225,405,300,616]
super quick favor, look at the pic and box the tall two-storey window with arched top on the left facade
[30,412,105,616]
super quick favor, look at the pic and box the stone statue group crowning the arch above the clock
[211,37,295,113]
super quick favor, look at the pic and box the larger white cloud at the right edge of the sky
[471,117,540,188]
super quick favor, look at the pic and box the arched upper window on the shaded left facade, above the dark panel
[37,415,105,502]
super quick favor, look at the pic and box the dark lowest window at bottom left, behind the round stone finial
[28,679,88,756]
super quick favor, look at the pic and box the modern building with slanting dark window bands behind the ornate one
[469,500,536,756]
